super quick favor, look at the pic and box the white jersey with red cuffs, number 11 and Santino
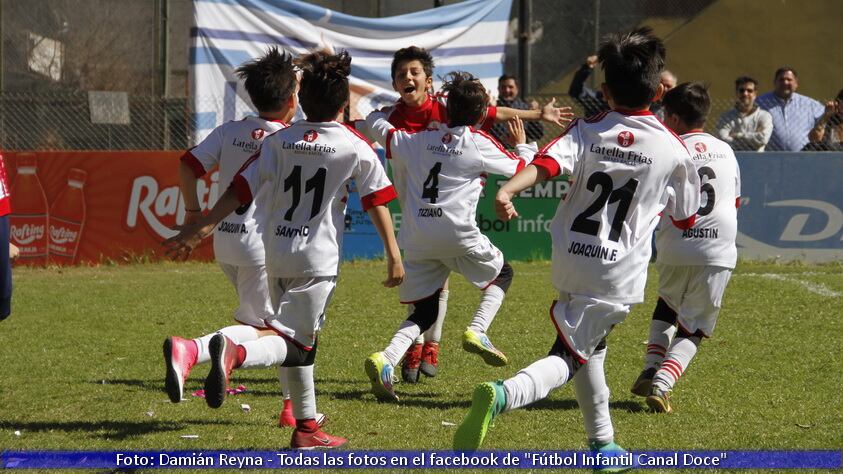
[233,120,395,278]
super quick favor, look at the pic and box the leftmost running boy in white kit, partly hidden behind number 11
[164,47,316,426]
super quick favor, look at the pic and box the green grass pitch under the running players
[0,261,843,468]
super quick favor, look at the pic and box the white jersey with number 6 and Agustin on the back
[656,133,741,268]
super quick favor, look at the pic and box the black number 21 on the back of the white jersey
[571,171,638,242]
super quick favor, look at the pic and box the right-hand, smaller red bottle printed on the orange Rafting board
[50,168,88,265]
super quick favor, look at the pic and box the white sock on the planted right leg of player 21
[574,349,615,443]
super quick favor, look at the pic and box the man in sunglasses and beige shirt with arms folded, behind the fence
[717,76,773,151]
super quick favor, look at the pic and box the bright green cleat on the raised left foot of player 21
[454,380,506,451]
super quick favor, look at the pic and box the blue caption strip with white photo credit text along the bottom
[0,450,843,470]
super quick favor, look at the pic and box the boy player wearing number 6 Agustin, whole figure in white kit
[631,82,741,413]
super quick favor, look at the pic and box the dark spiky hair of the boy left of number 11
[235,46,296,112]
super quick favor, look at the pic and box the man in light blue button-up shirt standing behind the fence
[756,66,823,151]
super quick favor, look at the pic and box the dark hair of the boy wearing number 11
[299,50,351,122]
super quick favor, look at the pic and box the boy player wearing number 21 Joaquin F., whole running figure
[454,28,699,462]
